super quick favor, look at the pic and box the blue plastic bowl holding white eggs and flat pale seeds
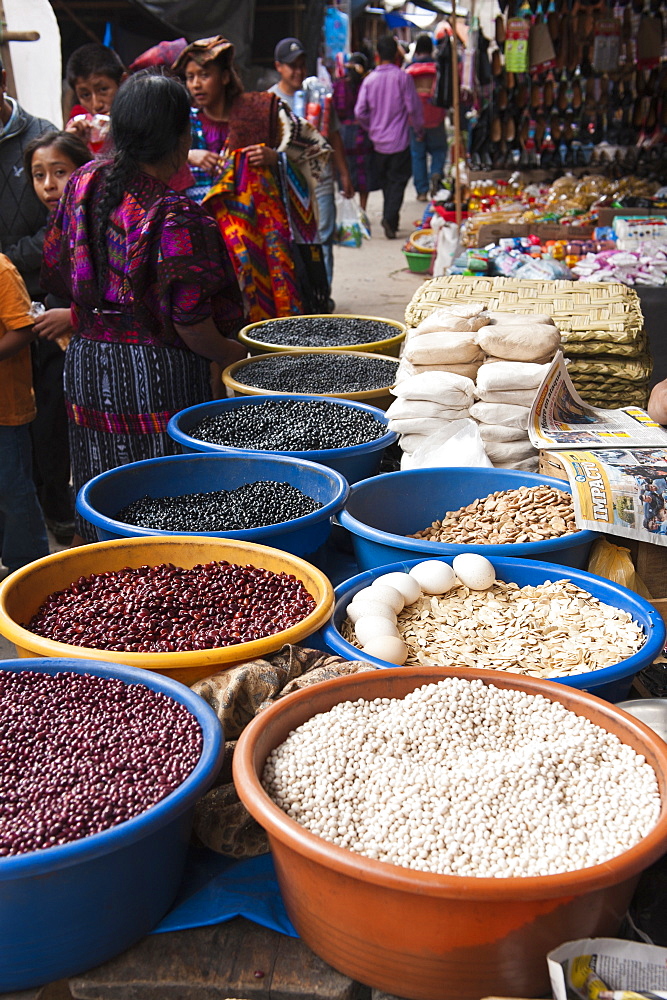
[322,556,665,702]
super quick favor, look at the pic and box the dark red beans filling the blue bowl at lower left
[0,670,202,864]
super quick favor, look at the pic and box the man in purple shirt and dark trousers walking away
[354,35,424,240]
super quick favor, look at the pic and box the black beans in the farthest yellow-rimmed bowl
[250,316,400,347]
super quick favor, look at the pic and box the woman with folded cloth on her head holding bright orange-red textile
[172,35,329,323]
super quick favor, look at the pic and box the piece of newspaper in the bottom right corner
[547,938,667,1000]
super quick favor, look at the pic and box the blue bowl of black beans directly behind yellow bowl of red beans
[76,451,349,556]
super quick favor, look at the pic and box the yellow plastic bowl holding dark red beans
[0,535,334,684]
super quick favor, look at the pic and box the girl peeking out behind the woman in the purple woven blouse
[24,131,91,543]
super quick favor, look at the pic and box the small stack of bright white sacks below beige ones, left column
[387,371,475,454]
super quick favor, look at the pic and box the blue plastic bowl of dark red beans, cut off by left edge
[0,659,224,992]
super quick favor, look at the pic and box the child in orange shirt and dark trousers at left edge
[0,254,49,578]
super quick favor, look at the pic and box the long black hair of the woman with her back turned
[94,70,190,292]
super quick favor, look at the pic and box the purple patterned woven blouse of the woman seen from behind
[42,163,243,347]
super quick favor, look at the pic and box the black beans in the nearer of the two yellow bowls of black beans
[234,351,398,396]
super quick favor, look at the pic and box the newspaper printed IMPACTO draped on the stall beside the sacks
[530,352,667,545]
